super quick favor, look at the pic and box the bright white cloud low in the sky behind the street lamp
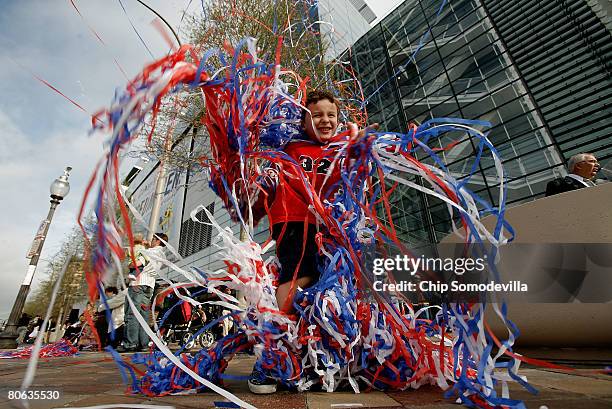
[0,111,101,316]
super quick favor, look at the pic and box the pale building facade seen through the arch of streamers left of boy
[127,127,249,280]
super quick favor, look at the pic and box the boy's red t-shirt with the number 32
[268,141,341,225]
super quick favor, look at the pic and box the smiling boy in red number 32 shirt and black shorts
[249,91,376,394]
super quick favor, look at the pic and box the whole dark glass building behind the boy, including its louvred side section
[343,0,612,243]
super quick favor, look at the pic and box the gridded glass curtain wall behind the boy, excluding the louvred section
[344,0,610,243]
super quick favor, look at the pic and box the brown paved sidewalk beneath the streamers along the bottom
[0,351,612,409]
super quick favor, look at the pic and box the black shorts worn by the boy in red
[272,222,320,285]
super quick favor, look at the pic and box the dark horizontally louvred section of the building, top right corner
[484,0,612,165]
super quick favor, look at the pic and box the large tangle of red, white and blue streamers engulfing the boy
[79,34,531,408]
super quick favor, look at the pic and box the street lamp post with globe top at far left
[0,167,72,348]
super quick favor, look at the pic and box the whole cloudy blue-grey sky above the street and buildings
[0,0,401,319]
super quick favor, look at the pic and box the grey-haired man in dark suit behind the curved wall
[546,153,600,196]
